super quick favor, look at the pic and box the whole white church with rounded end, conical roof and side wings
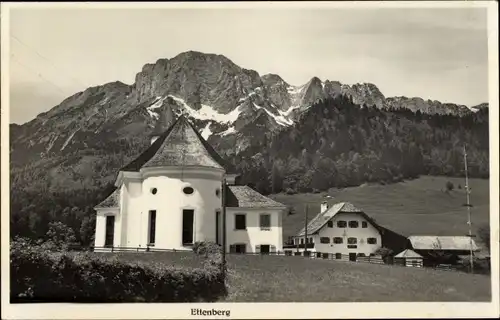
[94,109,286,253]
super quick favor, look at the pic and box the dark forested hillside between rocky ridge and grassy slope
[234,96,489,193]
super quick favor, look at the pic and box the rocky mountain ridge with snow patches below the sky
[10,51,488,194]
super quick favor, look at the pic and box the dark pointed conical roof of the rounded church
[120,116,234,173]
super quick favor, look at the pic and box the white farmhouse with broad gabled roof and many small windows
[293,202,407,261]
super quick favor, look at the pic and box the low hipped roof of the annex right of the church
[226,186,285,208]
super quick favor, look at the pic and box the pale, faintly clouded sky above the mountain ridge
[9,8,488,124]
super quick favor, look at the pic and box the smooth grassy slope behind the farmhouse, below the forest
[270,176,490,249]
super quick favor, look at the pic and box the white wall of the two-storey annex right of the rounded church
[226,208,283,252]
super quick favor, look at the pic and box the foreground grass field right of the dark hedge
[225,255,491,302]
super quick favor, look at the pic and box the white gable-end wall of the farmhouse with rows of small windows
[294,213,382,256]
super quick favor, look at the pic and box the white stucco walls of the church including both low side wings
[95,168,283,252]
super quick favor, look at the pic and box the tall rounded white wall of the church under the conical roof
[114,168,222,250]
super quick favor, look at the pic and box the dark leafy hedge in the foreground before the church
[10,241,227,302]
